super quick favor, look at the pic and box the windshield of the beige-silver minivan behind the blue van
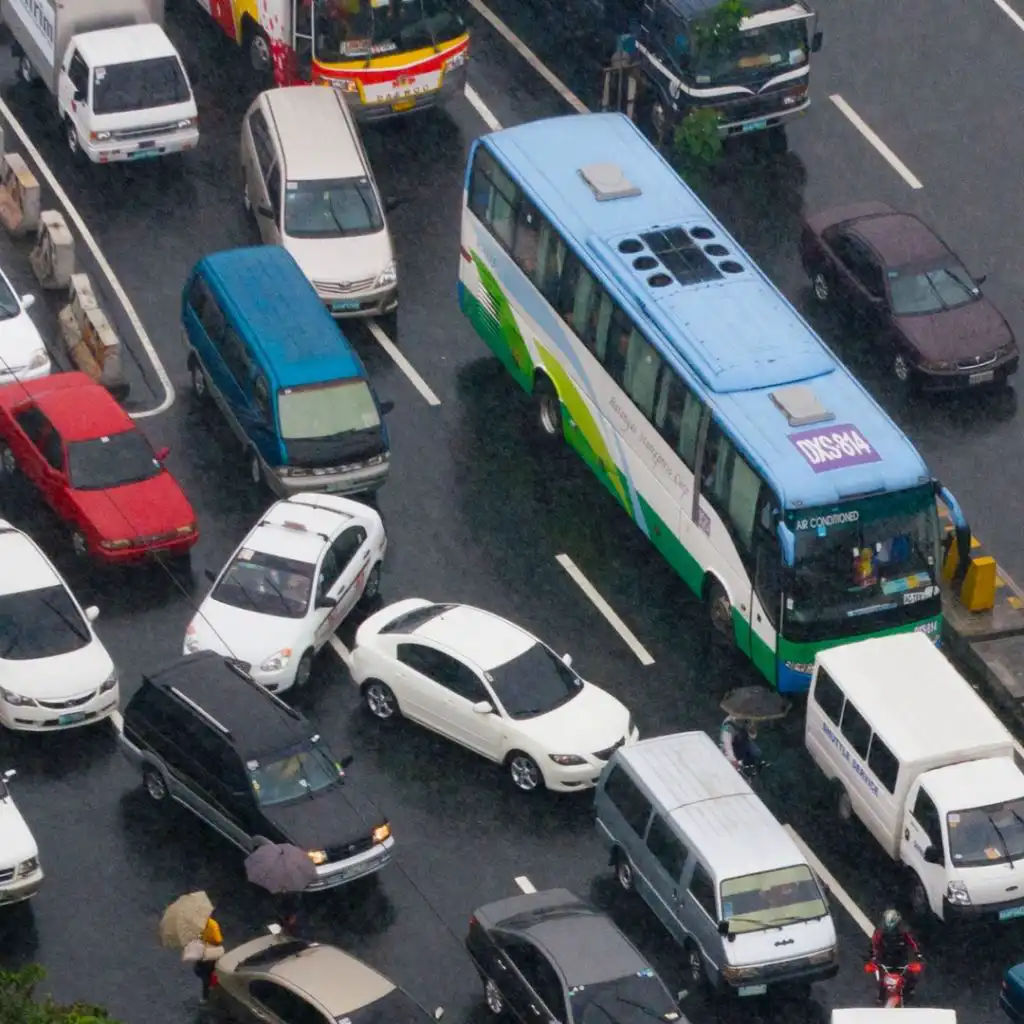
[285,178,384,239]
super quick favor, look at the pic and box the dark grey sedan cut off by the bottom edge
[466,889,682,1024]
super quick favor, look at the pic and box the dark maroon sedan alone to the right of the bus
[801,203,1019,389]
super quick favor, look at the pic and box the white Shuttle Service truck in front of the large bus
[804,633,1024,921]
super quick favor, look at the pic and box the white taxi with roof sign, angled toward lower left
[184,494,387,693]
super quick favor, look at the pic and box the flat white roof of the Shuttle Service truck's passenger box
[816,633,1014,762]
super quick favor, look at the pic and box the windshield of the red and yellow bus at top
[315,0,466,63]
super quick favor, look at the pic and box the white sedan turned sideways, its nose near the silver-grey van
[351,598,639,793]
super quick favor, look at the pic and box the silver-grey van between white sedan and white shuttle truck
[595,732,839,996]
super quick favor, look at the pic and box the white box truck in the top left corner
[0,0,199,164]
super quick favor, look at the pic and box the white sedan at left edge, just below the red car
[0,519,119,732]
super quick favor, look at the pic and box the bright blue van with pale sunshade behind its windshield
[181,246,393,497]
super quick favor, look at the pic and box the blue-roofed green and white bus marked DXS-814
[459,114,958,692]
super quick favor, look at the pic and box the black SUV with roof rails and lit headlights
[118,651,394,890]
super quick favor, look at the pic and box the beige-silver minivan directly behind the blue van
[241,86,398,317]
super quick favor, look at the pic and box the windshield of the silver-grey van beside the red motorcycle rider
[722,864,828,933]
